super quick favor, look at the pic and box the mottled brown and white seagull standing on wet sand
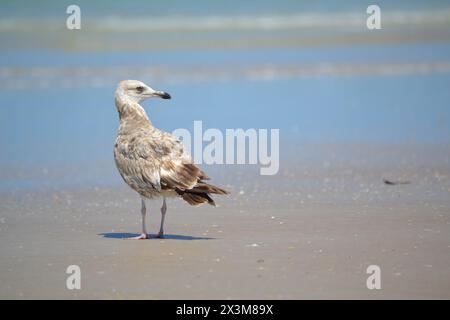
[114,80,228,240]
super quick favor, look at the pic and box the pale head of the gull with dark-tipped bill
[116,80,170,103]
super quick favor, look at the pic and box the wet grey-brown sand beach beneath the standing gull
[0,147,450,299]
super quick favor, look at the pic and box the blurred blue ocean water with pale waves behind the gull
[0,1,450,190]
